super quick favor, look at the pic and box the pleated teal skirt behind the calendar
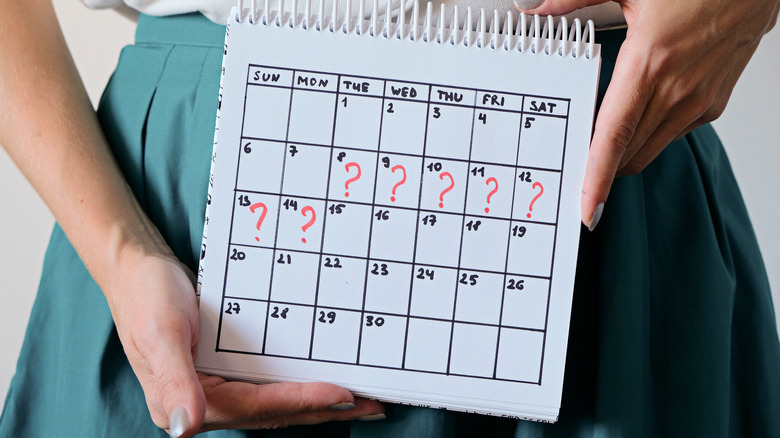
[0,11,780,438]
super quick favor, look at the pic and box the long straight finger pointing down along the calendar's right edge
[581,40,652,230]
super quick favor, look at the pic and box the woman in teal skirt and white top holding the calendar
[0,0,780,436]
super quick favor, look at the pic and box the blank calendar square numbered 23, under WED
[365,260,412,315]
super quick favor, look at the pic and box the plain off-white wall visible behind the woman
[0,0,780,412]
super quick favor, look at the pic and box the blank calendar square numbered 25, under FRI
[455,270,504,325]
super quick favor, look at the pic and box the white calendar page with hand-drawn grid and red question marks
[196,9,599,421]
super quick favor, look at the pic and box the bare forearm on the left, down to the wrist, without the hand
[0,0,170,303]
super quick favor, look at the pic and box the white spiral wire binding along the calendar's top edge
[231,0,596,59]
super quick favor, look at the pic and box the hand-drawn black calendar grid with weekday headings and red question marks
[216,64,570,385]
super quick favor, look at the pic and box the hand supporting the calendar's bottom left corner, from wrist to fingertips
[106,250,384,436]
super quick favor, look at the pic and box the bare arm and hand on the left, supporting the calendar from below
[0,0,383,436]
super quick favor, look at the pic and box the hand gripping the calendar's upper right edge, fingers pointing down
[526,0,780,230]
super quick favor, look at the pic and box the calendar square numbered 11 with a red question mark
[466,164,515,219]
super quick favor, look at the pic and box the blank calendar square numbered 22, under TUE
[317,254,366,310]
